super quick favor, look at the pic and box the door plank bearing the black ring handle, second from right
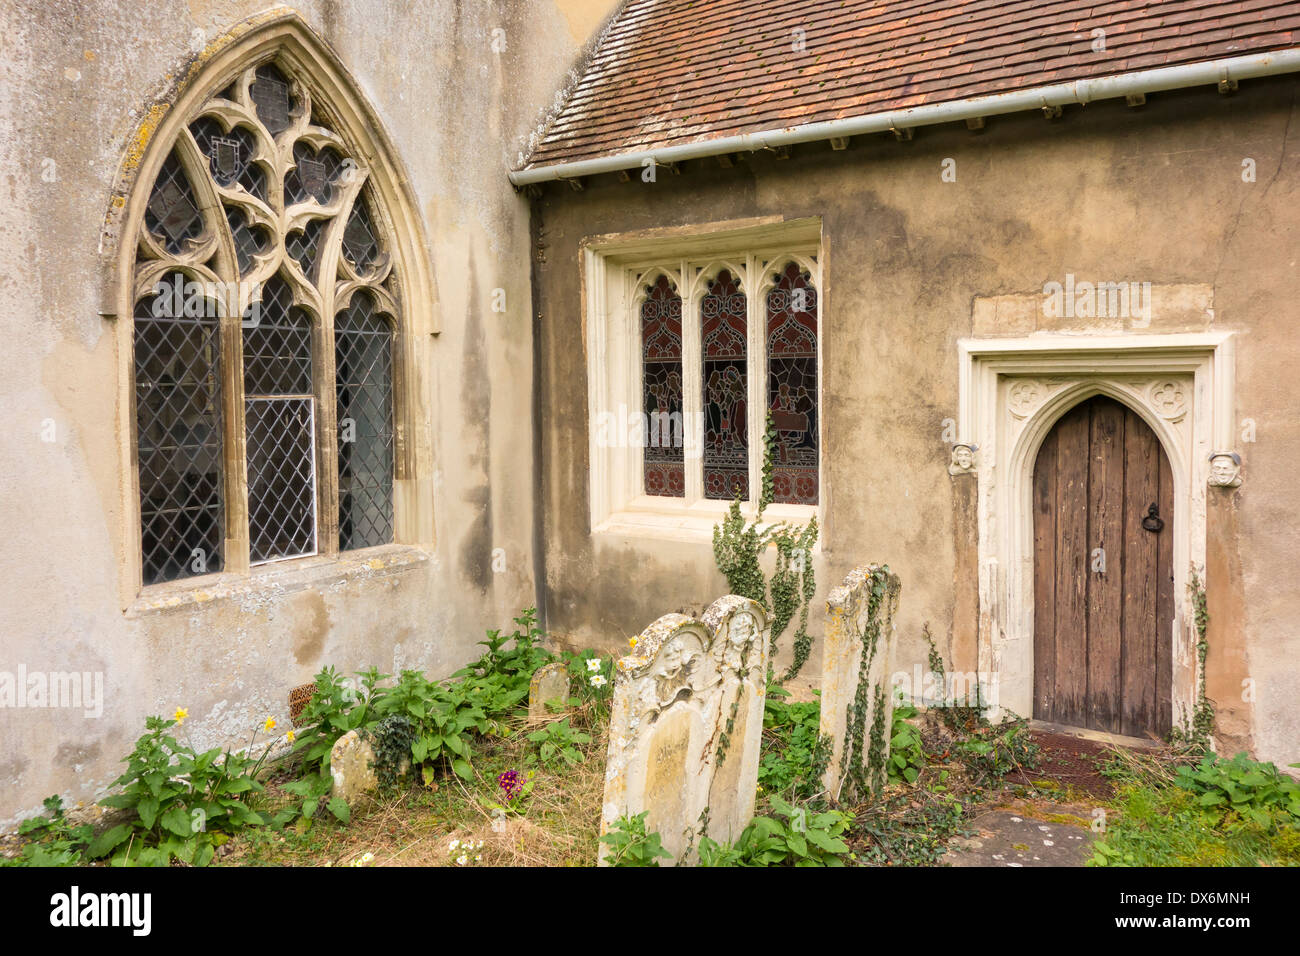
[1121,411,1174,737]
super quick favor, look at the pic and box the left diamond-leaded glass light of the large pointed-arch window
[134,276,225,584]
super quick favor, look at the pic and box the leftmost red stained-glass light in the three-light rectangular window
[641,276,686,498]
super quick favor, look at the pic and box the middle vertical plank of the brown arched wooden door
[1084,398,1126,734]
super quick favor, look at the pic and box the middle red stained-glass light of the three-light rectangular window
[699,269,749,499]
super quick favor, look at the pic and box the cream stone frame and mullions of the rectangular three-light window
[581,217,829,551]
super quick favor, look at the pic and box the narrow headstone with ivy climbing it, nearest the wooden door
[819,564,901,801]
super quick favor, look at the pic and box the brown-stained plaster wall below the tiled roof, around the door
[534,79,1300,763]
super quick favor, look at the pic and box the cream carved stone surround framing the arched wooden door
[954,332,1235,727]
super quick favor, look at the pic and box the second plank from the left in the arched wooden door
[1053,403,1091,727]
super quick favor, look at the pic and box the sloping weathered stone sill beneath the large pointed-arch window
[126,545,429,618]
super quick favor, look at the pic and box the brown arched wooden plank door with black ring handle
[1034,395,1174,737]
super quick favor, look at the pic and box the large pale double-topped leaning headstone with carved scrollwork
[599,594,768,865]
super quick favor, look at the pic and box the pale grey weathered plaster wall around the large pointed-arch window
[0,0,614,823]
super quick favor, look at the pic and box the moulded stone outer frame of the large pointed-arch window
[99,8,439,617]
